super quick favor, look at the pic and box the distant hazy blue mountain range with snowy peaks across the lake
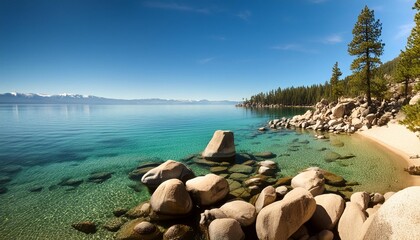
[0,92,239,105]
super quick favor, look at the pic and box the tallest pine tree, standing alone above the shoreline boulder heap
[348,6,385,105]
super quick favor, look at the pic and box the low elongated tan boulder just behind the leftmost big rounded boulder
[141,160,194,188]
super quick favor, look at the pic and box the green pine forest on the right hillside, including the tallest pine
[244,1,420,106]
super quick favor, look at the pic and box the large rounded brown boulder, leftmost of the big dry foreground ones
[150,179,193,215]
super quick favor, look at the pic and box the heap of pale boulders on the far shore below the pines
[269,98,403,133]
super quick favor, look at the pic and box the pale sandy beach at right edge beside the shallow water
[357,123,420,186]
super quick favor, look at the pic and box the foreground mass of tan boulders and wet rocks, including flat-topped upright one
[72,131,420,240]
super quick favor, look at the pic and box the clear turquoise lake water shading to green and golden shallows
[0,105,406,239]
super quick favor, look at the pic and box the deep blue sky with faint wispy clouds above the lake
[0,0,415,100]
